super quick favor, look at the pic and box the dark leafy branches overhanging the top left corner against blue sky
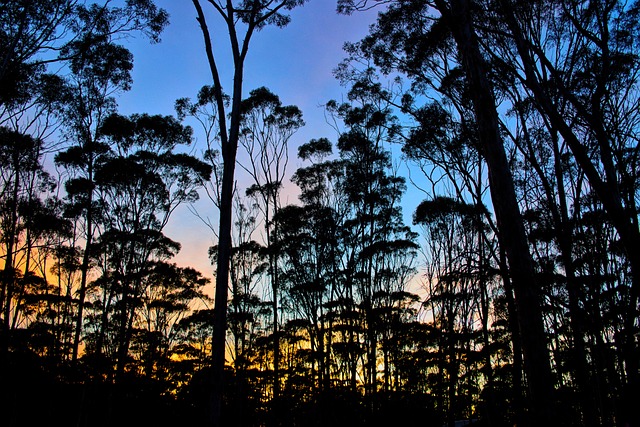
[0,0,168,119]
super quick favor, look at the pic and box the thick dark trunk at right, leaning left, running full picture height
[435,0,554,425]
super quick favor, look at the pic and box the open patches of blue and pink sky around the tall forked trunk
[118,0,420,288]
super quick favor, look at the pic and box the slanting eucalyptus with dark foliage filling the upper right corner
[484,1,640,417]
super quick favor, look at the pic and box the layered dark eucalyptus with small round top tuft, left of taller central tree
[276,138,344,392]
